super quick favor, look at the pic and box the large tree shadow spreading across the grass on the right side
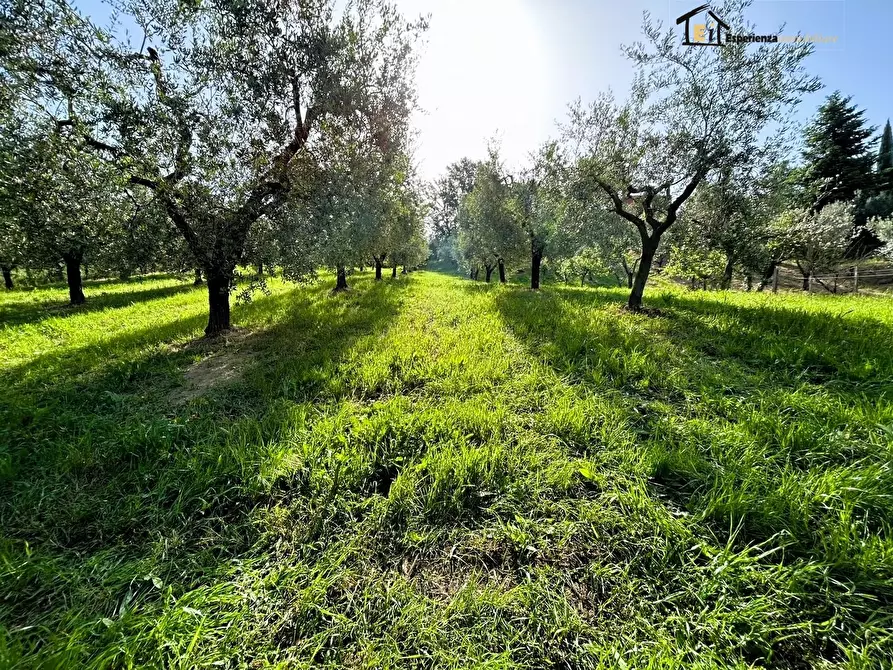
[494,288,893,602]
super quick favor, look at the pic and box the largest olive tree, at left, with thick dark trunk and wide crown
[0,0,424,335]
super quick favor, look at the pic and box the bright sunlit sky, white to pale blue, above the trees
[77,0,893,184]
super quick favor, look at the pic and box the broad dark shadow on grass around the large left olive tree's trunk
[0,280,409,650]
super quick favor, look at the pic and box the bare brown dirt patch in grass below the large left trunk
[169,329,256,405]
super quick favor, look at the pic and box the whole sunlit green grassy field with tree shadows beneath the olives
[0,272,893,669]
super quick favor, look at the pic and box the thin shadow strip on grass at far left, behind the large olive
[0,282,205,328]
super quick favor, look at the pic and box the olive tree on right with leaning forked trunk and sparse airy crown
[565,0,819,310]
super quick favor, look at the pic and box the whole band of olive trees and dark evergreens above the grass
[6,0,893,328]
